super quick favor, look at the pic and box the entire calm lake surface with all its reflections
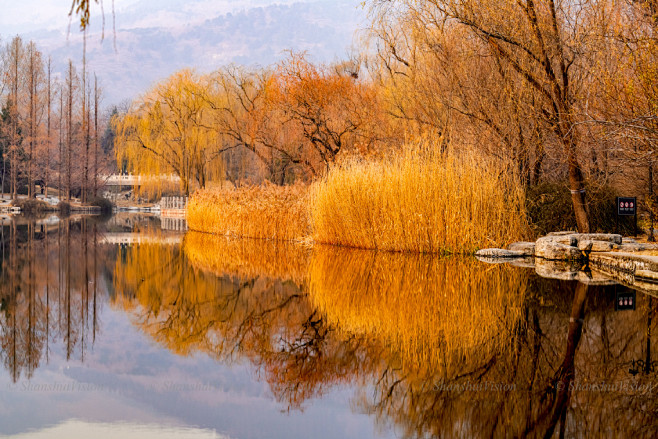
[0,215,658,438]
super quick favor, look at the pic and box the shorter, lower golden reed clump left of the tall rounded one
[187,183,310,240]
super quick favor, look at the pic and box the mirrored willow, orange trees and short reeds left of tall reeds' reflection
[115,234,377,408]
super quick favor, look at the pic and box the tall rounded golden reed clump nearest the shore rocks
[311,143,527,254]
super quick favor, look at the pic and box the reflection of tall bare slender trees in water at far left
[0,220,109,382]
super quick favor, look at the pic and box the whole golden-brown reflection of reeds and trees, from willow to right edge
[106,234,656,437]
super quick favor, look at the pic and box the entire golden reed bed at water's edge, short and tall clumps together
[187,145,528,254]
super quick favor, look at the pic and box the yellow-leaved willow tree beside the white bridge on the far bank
[112,70,223,194]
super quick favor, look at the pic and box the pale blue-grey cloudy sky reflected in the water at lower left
[0,282,390,438]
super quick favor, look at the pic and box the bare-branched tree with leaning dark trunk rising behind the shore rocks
[370,0,605,232]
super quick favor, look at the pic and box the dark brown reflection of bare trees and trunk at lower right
[352,276,656,437]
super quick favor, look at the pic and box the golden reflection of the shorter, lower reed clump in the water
[183,232,310,285]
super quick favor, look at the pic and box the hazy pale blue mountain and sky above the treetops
[24,0,365,105]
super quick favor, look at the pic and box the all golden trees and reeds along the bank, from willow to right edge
[113,0,658,248]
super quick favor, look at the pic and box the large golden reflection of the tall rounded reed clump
[309,247,527,370]
